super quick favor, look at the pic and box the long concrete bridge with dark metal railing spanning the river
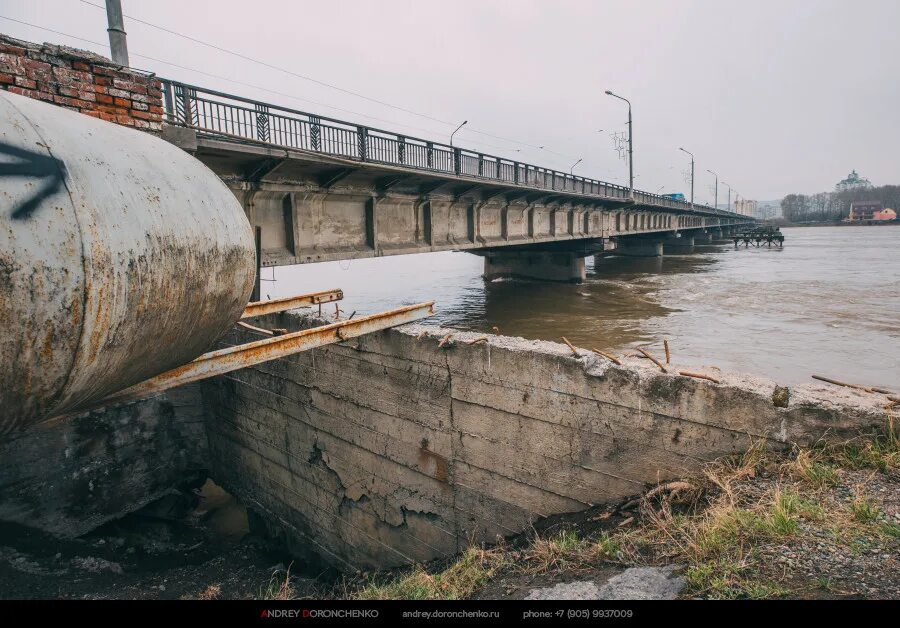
[162,80,752,281]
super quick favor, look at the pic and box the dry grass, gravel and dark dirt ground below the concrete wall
[0,415,900,600]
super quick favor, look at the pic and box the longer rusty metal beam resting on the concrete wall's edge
[102,301,434,405]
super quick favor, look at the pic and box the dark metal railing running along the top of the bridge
[162,79,736,216]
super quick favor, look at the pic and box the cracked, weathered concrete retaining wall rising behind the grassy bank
[202,314,885,569]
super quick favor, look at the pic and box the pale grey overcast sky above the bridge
[0,0,900,203]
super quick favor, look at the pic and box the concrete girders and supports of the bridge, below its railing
[164,127,747,279]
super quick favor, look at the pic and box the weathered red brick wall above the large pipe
[0,34,163,132]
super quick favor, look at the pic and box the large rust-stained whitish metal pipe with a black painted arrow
[0,91,256,434]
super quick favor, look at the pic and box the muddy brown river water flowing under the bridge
[262,226,900,389]
